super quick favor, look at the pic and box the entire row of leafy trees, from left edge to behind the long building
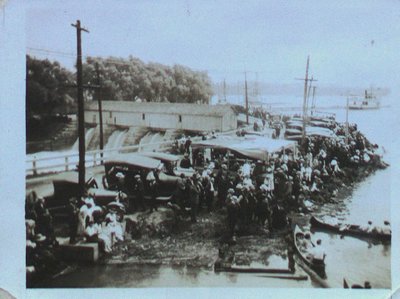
[26,56,213,114]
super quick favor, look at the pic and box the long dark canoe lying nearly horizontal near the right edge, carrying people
[310,216,392,241]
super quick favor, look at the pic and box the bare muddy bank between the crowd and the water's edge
[100,166,377,270]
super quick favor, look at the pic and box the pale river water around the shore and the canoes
[32,98,395,288]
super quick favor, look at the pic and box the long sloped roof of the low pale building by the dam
[85,101,233,116]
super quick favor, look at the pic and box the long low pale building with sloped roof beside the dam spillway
[85,101,237,132]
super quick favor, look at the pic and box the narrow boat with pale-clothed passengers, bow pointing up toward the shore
[293,225,326,278]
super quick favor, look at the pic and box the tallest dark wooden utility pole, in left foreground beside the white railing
[71,20,89,196]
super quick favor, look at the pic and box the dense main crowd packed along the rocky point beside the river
[168,116,386,240]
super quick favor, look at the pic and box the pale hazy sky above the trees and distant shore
[26,0,400,88]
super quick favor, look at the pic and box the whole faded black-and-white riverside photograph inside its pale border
[3,0,400,296]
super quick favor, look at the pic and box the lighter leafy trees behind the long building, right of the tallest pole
[83,56,212,103]
